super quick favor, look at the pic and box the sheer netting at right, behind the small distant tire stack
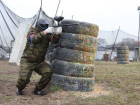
[95,29,138,60]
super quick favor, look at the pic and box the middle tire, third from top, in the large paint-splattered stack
[54,47,95,64]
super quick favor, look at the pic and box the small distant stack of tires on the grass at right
[117,44,129,64]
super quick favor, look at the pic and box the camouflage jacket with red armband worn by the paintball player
[22,27,60,62]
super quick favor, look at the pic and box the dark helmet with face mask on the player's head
[36,19,49,31]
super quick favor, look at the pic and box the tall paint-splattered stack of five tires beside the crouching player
[51,20,99,91]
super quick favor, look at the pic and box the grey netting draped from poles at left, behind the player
[0,0,55,53]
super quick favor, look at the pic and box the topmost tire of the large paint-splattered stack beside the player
[61,20,99,37]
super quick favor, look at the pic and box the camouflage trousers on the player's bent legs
[16,58,52,90]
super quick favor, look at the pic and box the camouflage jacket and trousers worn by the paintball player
[17,28,60,90]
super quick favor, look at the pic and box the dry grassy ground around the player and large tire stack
[0,61,140,105]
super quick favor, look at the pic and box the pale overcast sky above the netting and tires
[2,0,140,36]
